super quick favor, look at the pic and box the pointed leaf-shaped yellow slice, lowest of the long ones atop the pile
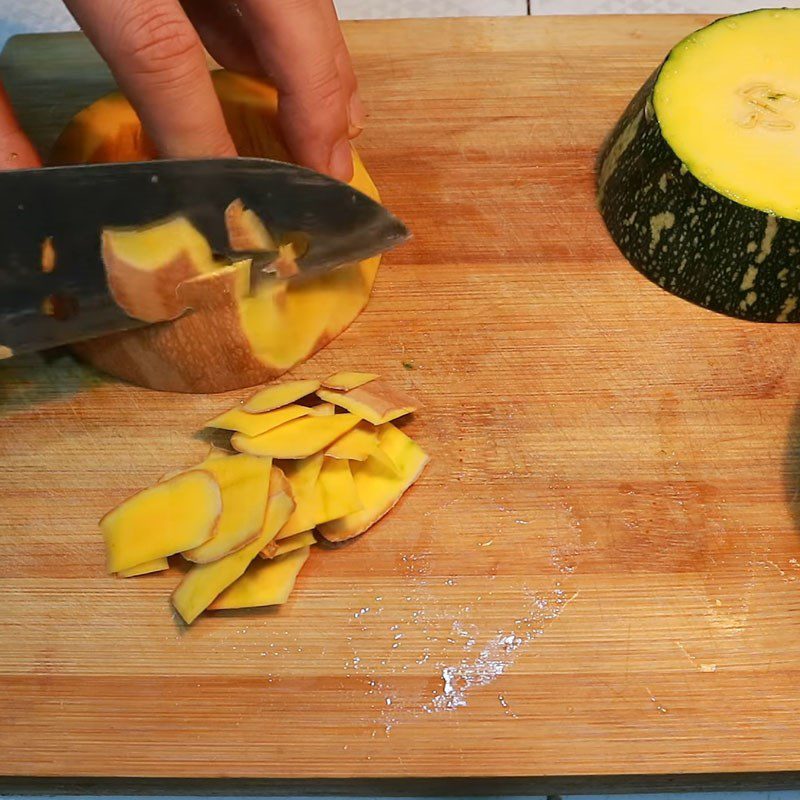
[231,414,359,459]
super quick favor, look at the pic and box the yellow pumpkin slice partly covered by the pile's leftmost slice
[183,455,272,564]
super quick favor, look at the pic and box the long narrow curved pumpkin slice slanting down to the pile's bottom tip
[172,468,294,624]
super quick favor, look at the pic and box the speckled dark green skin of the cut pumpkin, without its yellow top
[597,69,800,322]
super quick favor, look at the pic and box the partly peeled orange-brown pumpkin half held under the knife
[49,70,380,392]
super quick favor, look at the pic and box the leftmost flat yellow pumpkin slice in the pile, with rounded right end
[100,470,222,572]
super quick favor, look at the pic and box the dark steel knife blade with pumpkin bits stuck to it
[0,158,410,359]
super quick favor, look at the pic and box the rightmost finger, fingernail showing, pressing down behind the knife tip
[236,0,353,180]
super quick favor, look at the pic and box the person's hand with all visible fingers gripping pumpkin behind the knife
[0,0,364,180]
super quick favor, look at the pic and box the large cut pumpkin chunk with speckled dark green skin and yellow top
[597,9,800,322]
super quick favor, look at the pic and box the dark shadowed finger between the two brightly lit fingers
[181,0,264,75]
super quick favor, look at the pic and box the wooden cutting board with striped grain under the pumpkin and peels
[0,17,800,776]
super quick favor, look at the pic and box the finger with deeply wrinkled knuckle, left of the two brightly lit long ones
[66,0,236,158]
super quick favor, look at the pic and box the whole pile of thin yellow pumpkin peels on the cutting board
[100,372,428,623]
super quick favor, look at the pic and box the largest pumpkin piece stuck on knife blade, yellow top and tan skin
[101,217,216,322]
